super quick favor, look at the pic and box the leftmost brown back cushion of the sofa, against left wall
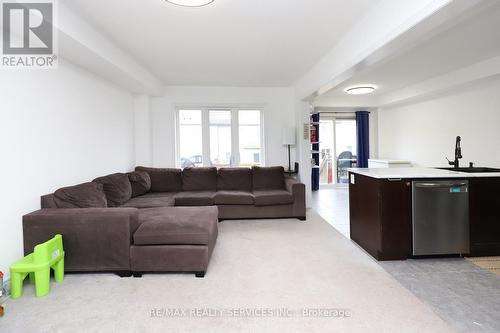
[54,183,108,208]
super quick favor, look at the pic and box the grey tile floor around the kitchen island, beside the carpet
[312,188,500,333]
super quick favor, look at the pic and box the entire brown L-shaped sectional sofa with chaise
[23,167,306,276]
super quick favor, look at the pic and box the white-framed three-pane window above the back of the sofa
[177,108,264,168]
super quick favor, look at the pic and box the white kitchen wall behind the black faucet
[378,78,500,167]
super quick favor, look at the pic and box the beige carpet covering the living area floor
[0,211,451,333]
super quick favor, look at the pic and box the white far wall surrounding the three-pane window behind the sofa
[152,86,295,167]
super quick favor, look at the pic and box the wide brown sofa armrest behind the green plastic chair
[23,208,139,271]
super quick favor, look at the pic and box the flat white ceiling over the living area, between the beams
[67,0,379,86]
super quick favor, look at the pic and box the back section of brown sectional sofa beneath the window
[124,167,305,220]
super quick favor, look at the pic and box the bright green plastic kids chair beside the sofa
[10,234,64,299]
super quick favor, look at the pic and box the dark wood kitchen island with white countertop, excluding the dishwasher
[349,168,500,260]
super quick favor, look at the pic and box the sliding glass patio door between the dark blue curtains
[319,112,357,188]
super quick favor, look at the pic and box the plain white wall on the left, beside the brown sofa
[0,62,134,280]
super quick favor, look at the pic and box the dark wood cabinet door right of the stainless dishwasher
[469,177,500,256]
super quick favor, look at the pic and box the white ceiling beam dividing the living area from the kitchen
[294,0,494,100]
